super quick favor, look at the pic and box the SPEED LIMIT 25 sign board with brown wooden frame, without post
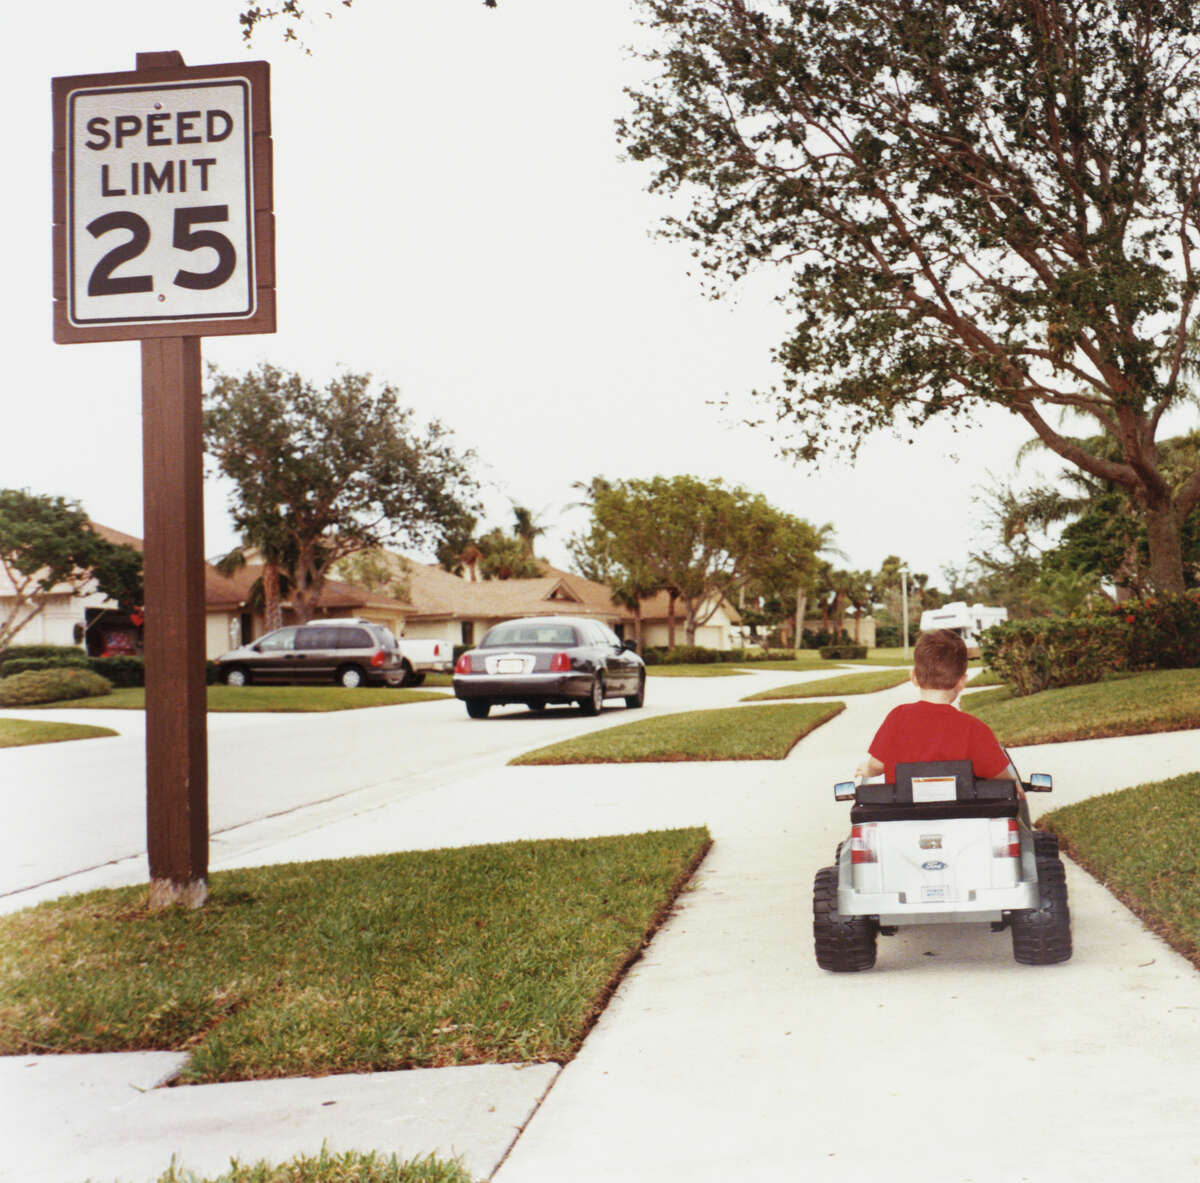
[53,62,275,343]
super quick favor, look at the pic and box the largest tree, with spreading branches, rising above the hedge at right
[619,0,1200,592]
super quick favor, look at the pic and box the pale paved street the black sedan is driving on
[0,672,814,912]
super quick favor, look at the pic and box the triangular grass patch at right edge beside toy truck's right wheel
[1039,773,1200,968]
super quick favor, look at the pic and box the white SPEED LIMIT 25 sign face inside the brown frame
[67,78,256,325]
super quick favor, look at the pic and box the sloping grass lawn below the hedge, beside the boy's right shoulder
[961,669,1200,746]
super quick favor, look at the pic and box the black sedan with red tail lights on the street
[454,617,646,719]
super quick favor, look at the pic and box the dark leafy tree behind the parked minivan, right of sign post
[204,365,475,621]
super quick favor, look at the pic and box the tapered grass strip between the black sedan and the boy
[509,702,846,764]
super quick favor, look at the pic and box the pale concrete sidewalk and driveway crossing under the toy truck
[0,687,1200,1183]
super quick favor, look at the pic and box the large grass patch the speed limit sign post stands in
[0,829,710,1082]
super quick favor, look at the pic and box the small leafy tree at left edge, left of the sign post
[0,488,142,653]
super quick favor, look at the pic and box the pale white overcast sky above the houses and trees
[7,0,1054,584]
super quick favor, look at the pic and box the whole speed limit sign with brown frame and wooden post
[53,52,275,908]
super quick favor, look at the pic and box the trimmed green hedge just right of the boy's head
[980,615,1129,696]
